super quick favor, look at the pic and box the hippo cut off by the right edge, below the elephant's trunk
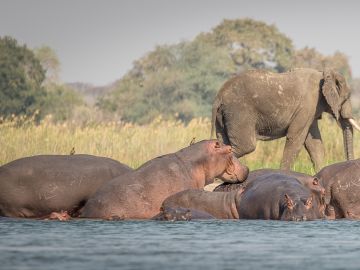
[316,159,360,219]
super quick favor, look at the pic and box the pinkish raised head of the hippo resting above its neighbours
[204,140,249,183]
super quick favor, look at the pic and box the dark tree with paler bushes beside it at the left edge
[0,37,83,121]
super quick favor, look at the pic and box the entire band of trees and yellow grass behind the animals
[0,19,360,174]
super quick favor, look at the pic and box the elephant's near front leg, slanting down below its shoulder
[281,112,311,170]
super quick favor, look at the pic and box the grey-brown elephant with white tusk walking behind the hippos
[211,68,360,171]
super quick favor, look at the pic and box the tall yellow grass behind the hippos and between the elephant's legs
[0,114,360,174]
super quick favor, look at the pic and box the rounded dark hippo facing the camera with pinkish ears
[237,173,323,221]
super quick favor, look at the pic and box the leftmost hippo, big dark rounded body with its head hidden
[0,155,132,218]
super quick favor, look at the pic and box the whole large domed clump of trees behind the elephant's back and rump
[98,19,293,123]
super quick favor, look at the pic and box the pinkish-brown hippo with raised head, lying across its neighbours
[81,140,248,219]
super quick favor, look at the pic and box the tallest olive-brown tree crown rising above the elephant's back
[198,19,294,72]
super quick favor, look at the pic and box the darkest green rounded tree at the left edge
[0,36,46,116]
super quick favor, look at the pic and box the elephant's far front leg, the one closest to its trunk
[305,120,325,172]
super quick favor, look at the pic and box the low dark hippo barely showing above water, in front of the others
[151,207,215,221]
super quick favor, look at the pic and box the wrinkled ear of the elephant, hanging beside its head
[322,70,341,120]
